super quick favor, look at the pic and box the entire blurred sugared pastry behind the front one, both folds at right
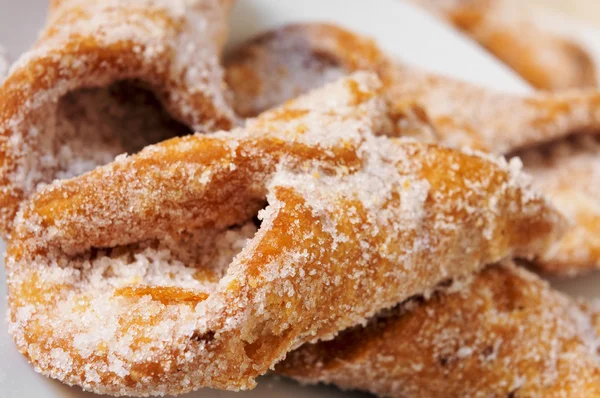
[226,24,600,275]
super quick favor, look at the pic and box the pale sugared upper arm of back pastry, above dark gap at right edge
[388,67,600,154]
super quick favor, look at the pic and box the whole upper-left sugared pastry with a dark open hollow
[0,0,234,235]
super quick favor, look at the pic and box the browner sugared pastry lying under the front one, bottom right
[276,266,600,398]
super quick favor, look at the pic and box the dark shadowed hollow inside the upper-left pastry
[34,82,190,187]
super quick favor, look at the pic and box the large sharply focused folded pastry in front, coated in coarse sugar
[6,73,562,395]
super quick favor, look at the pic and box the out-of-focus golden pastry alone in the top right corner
[411,0,598,90]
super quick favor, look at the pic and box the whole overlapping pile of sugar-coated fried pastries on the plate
[0,0,600,397]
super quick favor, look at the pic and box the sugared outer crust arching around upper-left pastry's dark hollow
[0,0,234,235]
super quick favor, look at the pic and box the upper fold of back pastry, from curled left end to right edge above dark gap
[226,24,600,154]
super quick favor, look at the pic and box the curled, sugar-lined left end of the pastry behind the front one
[224,24,381,117]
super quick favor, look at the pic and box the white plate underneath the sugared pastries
[0,0,590,398]
